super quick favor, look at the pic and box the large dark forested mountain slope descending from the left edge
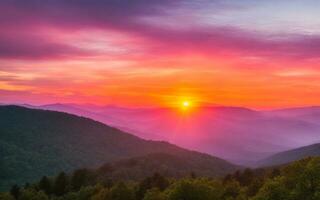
[0,106,236,189]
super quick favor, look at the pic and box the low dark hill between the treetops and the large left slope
[97,152,235,180]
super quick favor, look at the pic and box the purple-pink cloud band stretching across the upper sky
[0,0,320,59]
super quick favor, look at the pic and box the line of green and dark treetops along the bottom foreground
[0,157,320,200]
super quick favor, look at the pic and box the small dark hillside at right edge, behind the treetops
[257,143,320,167]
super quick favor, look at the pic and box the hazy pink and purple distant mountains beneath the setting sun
[28,104,320,165]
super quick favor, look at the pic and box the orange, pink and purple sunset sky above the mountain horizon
[0,0,320,109]
